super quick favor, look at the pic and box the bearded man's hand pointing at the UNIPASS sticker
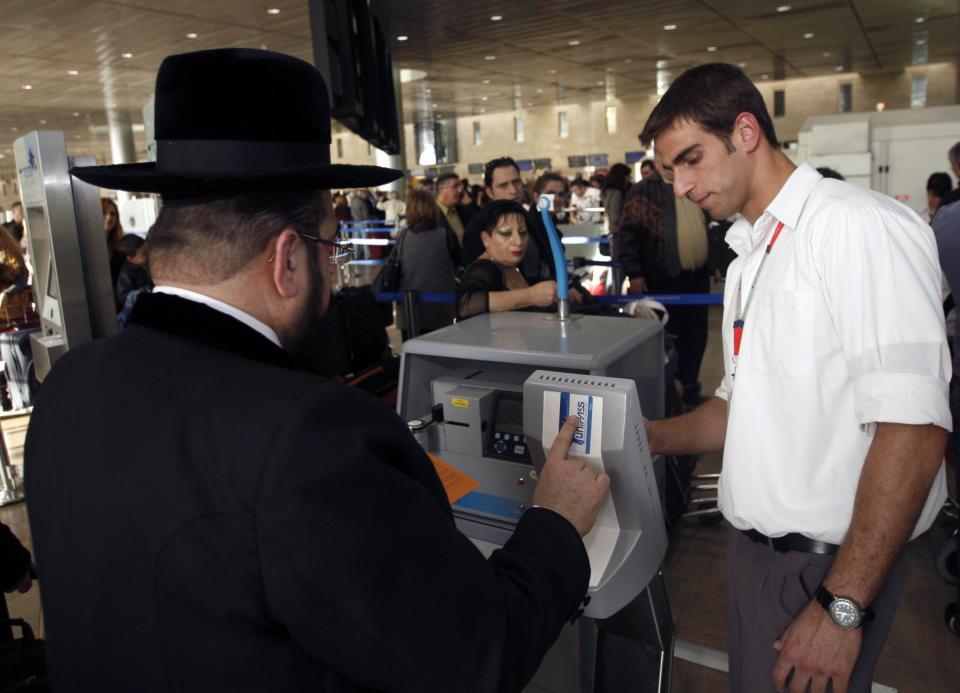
[533,416,610,537]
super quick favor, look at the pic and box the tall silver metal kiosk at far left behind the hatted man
[14,132,116,381]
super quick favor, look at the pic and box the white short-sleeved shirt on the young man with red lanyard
[716,164,951,544]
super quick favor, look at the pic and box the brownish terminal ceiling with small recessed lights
[0,0,960,178]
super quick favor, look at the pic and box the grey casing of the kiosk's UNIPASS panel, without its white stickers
[523,371,667,618]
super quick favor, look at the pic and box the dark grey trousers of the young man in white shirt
[727,528,906,693]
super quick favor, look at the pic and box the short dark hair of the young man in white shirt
[640,63,778,147]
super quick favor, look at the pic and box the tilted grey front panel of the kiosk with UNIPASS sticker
[523,370,667,619]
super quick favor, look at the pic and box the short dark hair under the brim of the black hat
[147,189,324,284]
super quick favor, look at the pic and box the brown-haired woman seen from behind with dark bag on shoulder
[397,190,463,341]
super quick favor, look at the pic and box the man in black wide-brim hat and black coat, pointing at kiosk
[26,50,608,693]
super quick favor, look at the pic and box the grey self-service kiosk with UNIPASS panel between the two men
[397,312,673,693]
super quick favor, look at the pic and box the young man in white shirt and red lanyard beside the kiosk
[641,63,951,693]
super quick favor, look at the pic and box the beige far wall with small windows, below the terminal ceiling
[396,63,958,182]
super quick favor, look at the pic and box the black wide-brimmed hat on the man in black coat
[71,48,403,198]
